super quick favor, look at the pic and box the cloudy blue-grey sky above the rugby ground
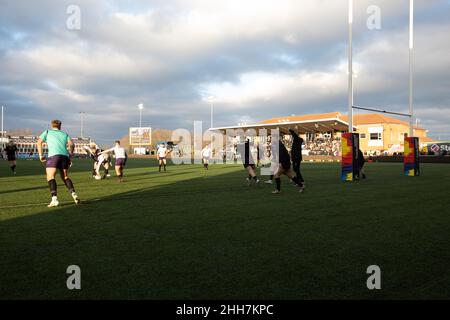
[0,0,450,143]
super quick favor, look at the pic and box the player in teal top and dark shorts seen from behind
[37,120,80,208]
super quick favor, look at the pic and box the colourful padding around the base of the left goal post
[341,132,359,181]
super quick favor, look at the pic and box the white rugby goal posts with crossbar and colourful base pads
[341,0,420,181]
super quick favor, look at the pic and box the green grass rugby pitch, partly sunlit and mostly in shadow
[0,159,450,299]
